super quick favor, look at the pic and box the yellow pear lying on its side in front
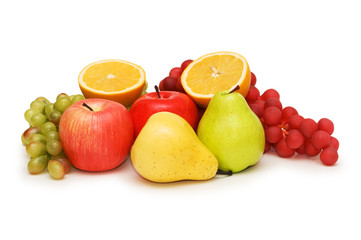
[130,112,218,183]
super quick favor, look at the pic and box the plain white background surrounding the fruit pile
[0,0,361,239]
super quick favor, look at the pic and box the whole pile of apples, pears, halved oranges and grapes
[22,52,339,182]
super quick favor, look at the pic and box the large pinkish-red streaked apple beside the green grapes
[59,98,134,172]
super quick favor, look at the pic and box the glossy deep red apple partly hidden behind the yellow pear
[129,91,199,137]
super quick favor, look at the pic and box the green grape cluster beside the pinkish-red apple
[21,93,84,179]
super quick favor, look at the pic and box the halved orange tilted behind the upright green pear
[181,52,251,108]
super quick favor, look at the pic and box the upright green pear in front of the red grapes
[197,91,265,172]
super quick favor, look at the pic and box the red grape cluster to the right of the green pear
[246,73,339,166]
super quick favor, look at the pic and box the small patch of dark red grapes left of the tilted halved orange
[159,59,193,93]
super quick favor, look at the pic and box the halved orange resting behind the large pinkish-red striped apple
[78,59,145,107]
